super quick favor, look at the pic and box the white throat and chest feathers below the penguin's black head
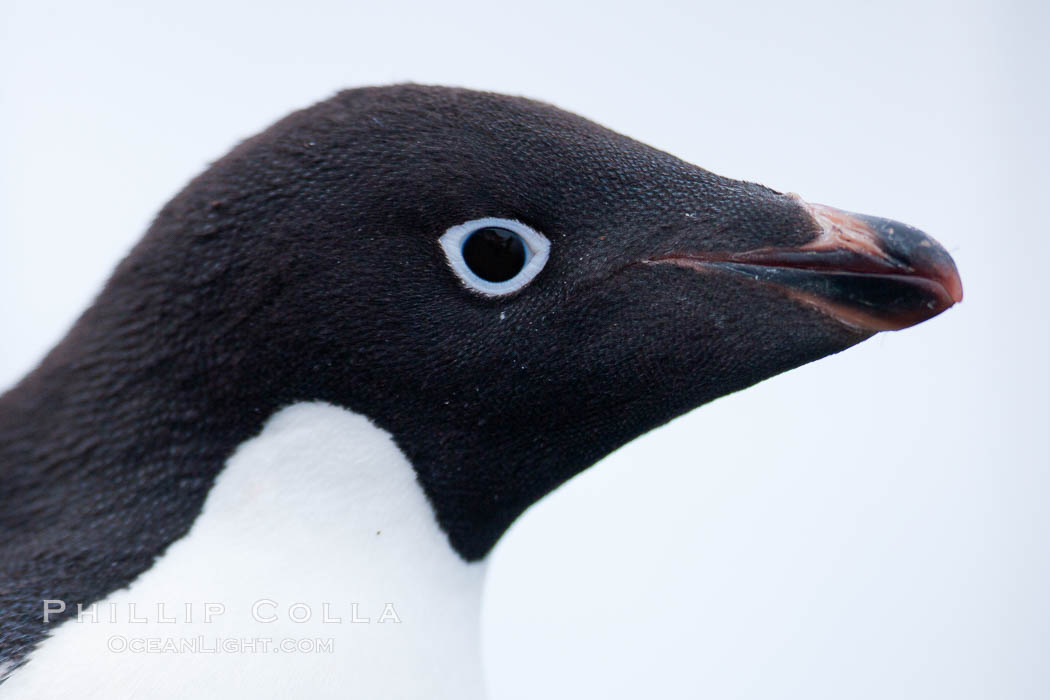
[0,403,484,700]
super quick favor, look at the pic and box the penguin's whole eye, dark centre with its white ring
[440,217,550,297]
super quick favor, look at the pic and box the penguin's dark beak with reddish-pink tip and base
[649,199,963,333]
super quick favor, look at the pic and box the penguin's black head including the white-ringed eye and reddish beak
[97,86,961,559]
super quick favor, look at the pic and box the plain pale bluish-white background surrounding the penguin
[0,0,1050,700]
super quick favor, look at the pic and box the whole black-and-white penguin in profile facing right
[0,85,962,699]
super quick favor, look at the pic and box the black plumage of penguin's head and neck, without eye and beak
[0,85,867,662]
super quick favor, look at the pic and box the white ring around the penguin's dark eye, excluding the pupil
[439,216,550,297]
